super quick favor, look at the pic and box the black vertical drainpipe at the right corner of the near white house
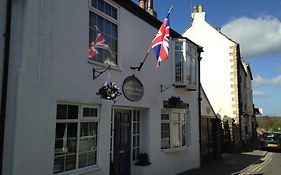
[197,47,203,167]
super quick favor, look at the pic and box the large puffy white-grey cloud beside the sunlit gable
[221,16,281,57]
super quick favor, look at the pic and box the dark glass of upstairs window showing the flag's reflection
[89,0,118,66]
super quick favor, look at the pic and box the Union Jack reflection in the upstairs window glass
[89,33,110,59]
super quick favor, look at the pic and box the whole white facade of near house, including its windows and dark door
[1,0,202,175]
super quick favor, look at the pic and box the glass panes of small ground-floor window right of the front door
[161,109,186,149]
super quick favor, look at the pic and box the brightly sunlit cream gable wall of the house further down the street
[183,12,235,119]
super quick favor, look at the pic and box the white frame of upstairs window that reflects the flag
[88,0,117,69]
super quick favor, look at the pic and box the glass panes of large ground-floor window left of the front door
[54,104,98,174]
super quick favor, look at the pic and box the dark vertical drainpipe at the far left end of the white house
[0,0,12,175]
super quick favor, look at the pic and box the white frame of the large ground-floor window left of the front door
[53,102,100,175]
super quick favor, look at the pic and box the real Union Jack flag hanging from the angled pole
[151,7,172,68]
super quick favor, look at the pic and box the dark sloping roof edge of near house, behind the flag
[113,0,203,51]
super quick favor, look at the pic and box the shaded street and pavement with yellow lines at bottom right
[180,150,281,175]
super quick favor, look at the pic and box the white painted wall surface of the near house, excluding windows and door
[3,0,200,175]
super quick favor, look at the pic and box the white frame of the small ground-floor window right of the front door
[161,108,188,152]
